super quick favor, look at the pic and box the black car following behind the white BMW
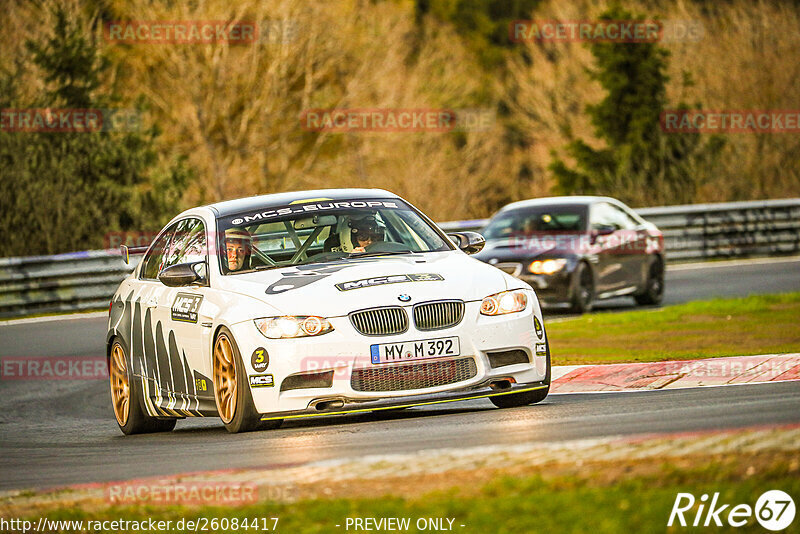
[474,196,664,313]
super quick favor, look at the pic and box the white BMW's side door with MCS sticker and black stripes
[156,217,214,414]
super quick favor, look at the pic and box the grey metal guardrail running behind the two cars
[0,198,800,317]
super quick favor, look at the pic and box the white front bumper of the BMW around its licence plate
[231,293,548,419]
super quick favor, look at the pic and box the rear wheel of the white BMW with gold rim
[108,338,178,435]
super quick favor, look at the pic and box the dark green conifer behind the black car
[549,7,722,205]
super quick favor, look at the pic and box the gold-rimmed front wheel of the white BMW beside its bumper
[212,326,283,434]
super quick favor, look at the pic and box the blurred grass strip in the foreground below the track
[26,453,800,534]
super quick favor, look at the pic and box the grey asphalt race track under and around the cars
[0,259,800,490]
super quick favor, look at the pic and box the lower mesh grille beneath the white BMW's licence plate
[350,358,478,392]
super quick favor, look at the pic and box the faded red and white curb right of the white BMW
[550,353,800,393]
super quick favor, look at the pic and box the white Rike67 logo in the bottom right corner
[667,490,796,532]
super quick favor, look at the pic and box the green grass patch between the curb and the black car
[547,293,800,365]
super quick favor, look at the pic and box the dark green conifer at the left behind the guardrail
[0,4,192,256]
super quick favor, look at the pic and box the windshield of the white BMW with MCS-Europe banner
[217,199,453,274]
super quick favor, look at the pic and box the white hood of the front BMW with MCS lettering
[214,252,522,317]
